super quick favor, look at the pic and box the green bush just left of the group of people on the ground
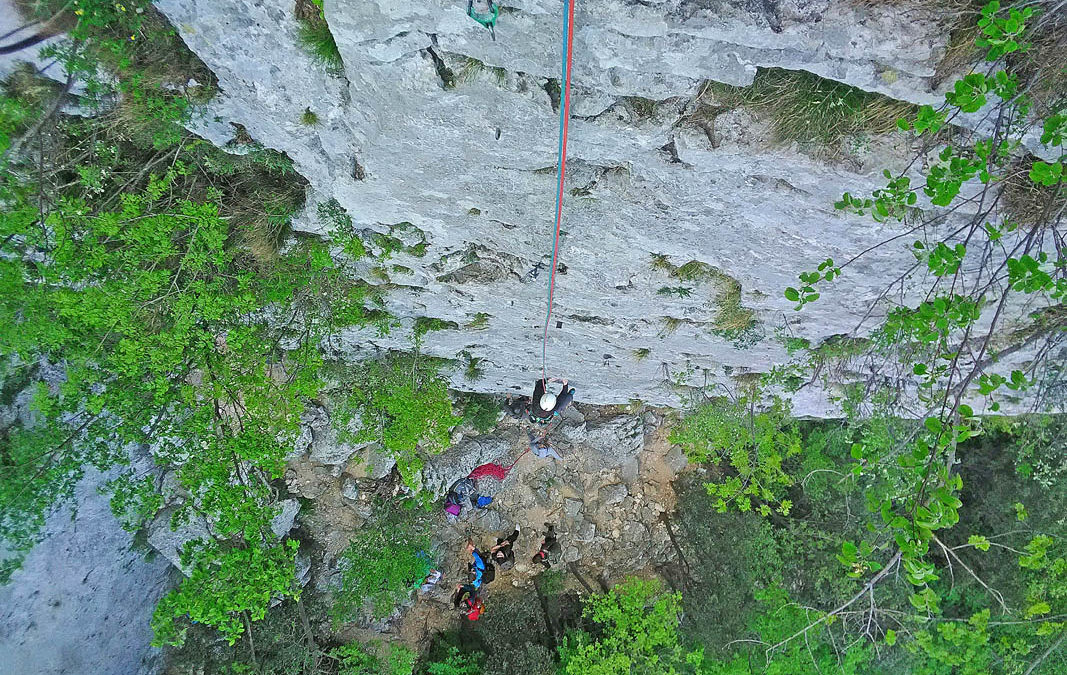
[331,501,432,623]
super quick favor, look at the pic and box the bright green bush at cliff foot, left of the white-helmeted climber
[333,354,461,488]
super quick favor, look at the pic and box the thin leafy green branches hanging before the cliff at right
[785,1,1067,635]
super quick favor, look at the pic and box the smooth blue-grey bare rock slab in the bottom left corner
[0,472,172,675]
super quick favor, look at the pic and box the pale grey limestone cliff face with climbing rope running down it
[158,0,964,415]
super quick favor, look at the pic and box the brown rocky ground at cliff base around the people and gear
[286,404,687,646]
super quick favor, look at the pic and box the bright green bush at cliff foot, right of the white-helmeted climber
[670,397,801,515]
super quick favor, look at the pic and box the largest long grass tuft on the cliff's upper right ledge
[707,68,915,147]
